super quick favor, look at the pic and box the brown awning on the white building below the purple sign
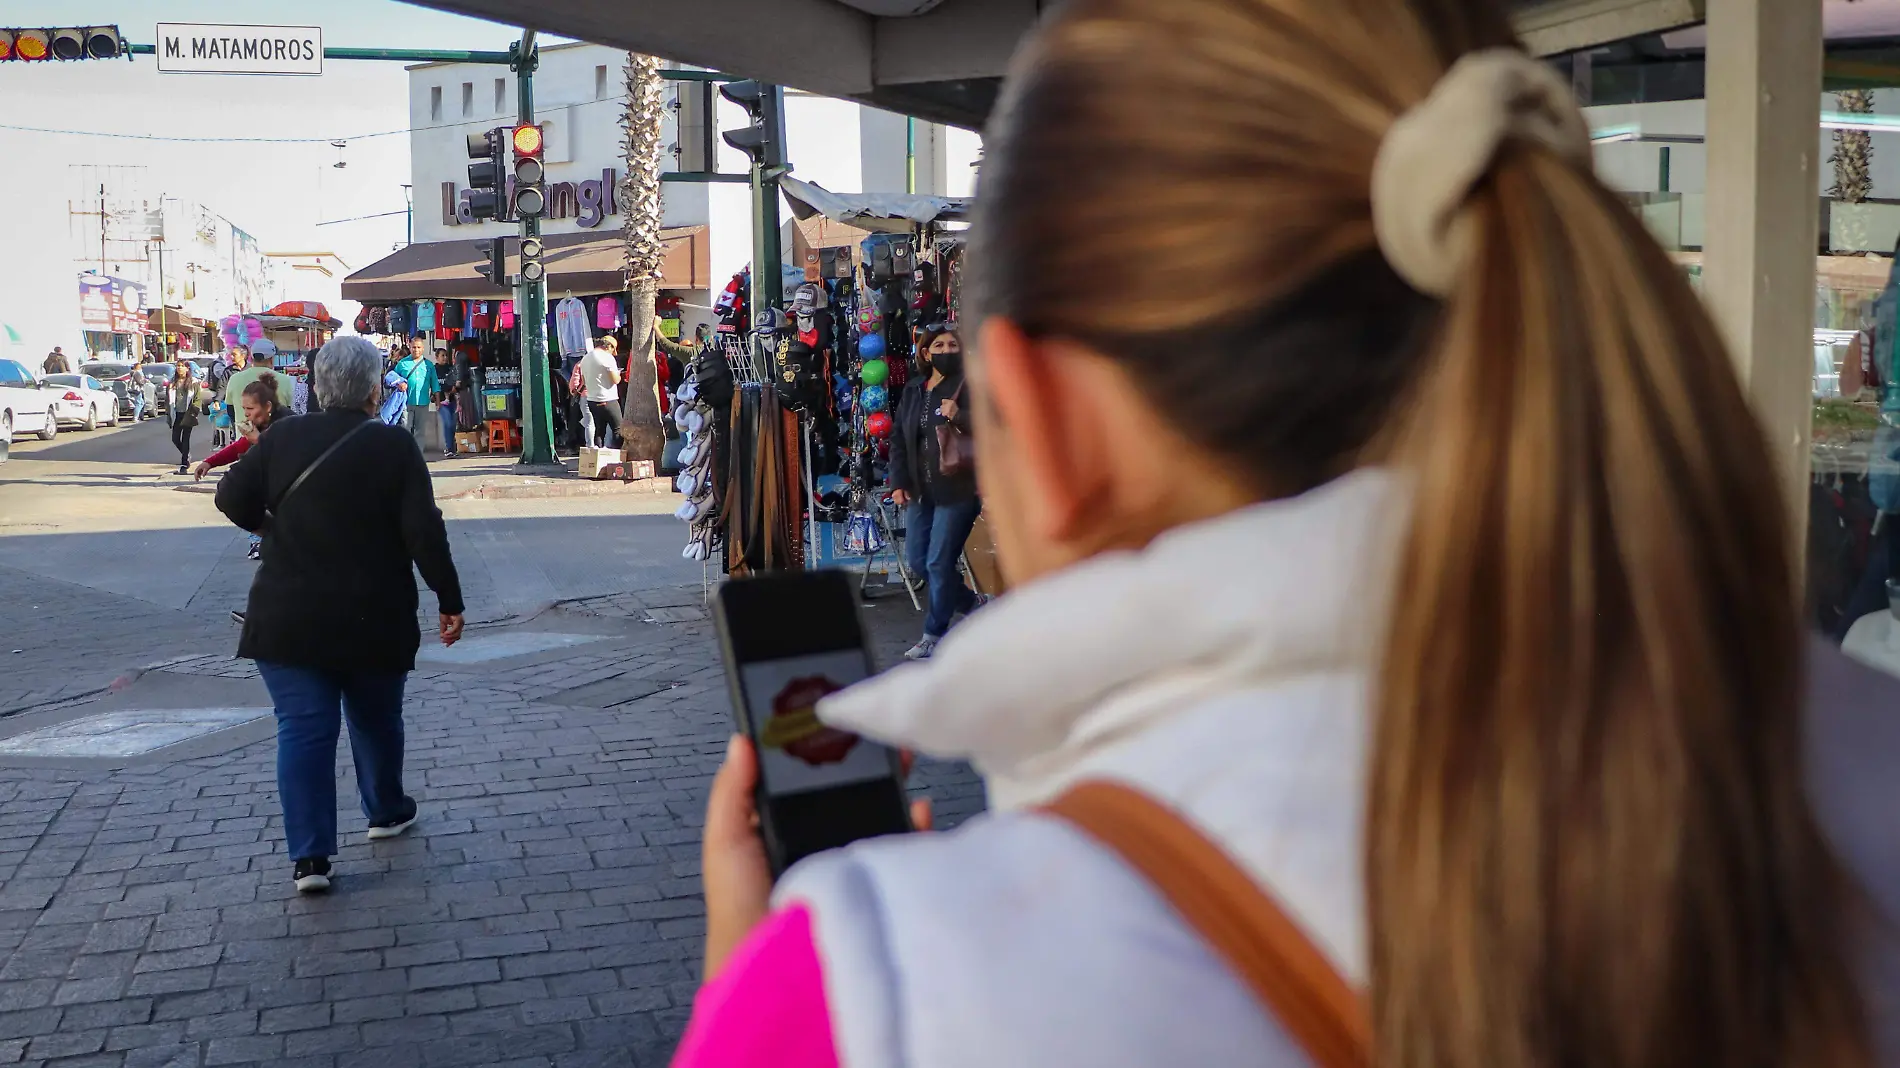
[342,226,713,304]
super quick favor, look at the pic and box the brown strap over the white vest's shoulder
[1043,781,1372,1068]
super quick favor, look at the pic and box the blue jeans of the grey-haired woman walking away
[257,659,416,861]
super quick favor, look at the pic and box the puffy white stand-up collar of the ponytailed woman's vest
[819,469,1406,810]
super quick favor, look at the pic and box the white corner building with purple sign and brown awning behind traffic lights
[344,44,977,304]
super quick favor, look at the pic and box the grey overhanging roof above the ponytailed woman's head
[412,0,1706,127]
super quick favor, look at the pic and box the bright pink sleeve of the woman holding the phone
[673,905,838,1068]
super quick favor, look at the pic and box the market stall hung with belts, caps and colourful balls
[676,179,969,585]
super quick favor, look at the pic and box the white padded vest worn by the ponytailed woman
[777,471,1900,1068]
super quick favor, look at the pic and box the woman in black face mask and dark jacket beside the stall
[891,327,982,659]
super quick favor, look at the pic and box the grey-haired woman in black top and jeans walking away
[217,336,462,891]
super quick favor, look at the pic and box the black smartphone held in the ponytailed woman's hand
[713,570,910,876]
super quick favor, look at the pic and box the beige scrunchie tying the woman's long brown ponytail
[1372,48,1590,296]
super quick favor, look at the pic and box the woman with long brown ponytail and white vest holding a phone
[675,0,1900,1068]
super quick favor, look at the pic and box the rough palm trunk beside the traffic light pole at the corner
[619,51,667,466]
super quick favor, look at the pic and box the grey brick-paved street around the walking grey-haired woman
[0,424,980,1068]
